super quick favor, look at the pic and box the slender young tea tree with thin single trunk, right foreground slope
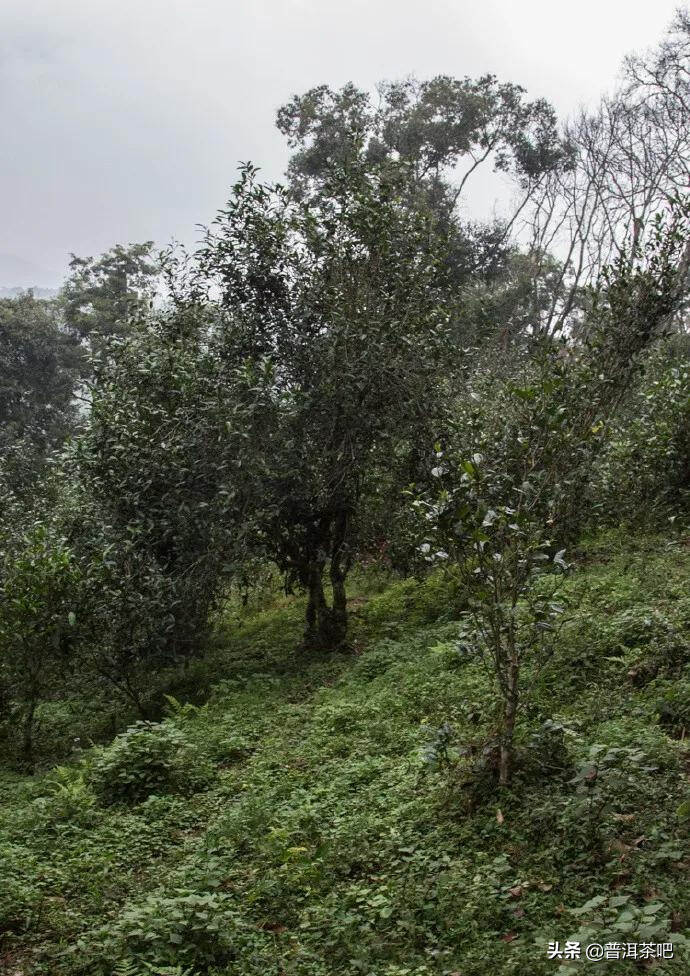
[416,350,568,785]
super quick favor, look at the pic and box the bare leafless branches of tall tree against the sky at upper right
[525,11,690,333]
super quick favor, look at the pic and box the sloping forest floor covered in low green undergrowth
[0,533,690,976]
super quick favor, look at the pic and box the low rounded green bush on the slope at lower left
[89,722,212,803]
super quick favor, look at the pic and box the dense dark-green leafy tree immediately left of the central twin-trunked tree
[66,304,264,689]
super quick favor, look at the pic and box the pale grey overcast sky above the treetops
[0,0,677,287]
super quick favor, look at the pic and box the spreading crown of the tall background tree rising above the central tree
[277,75,564,288]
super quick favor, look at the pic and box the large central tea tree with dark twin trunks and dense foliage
[188,162,451,646]
